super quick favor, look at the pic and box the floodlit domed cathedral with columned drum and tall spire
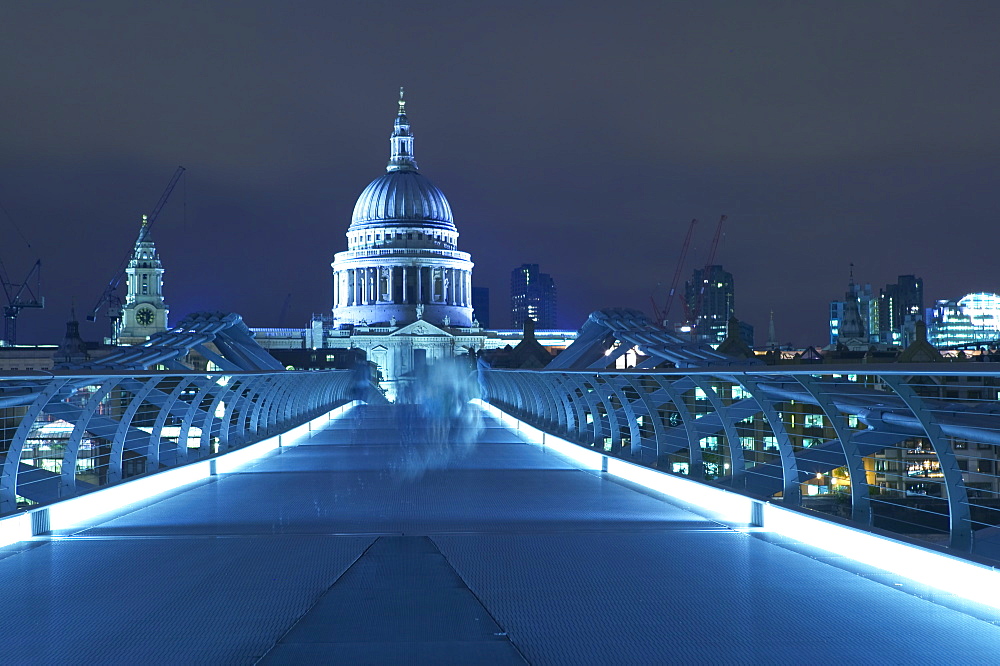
[324,90,486,400]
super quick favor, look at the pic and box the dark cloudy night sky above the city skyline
[0,0,1000,345]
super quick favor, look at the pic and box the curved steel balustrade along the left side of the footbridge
[0,370,358,515]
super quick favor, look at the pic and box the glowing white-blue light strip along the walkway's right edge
[473,399,1000,608]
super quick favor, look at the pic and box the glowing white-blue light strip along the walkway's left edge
[0,400,361,547]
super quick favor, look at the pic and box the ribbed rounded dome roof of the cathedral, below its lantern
[350,169,455,231]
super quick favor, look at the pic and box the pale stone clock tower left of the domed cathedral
[118,215,169,345]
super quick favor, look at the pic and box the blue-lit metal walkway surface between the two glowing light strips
[0,406,1000,664]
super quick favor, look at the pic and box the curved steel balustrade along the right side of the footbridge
[480,363,1000,559]
